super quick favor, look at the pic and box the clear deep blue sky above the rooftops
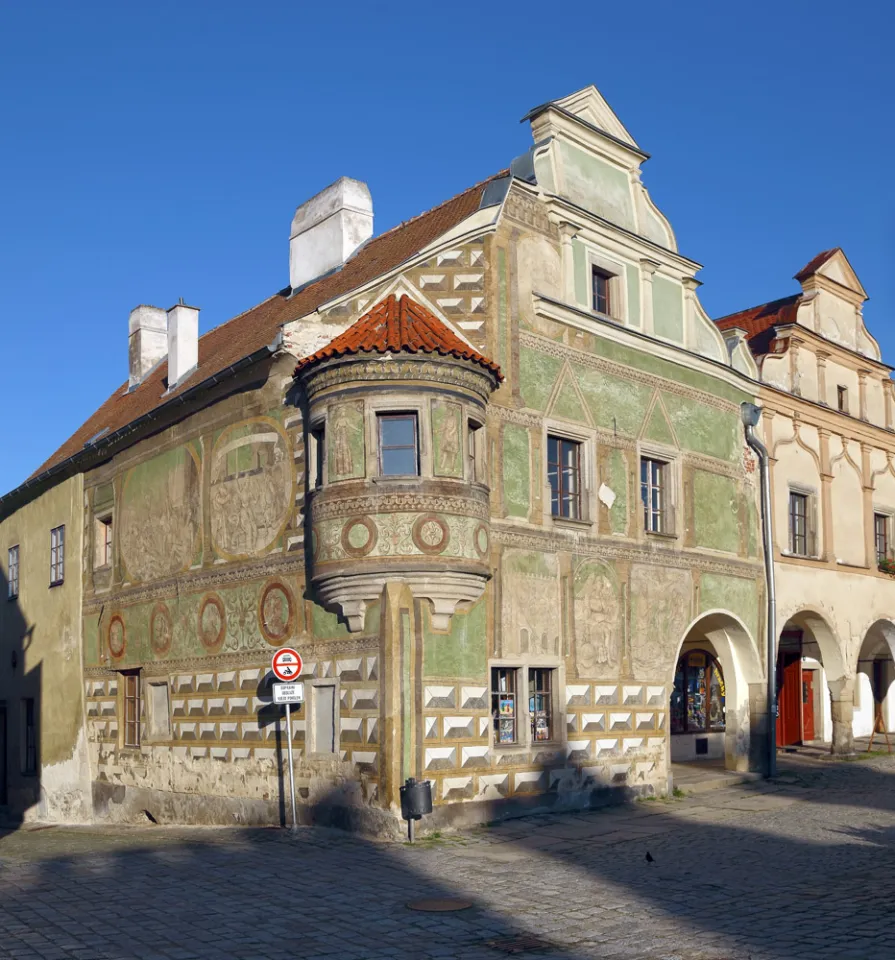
[0,0,895,492]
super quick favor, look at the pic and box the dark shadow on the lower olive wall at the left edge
[0,570,42,829]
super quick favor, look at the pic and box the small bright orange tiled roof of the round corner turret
[295,294,503,380]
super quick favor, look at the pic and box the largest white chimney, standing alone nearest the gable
[289,177,373,290]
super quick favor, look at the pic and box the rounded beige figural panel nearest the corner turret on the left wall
[210,417,294,560]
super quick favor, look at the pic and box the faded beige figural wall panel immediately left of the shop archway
[630,564,693,679]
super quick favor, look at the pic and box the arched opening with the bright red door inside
[777,610,851,748]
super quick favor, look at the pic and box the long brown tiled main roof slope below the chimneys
[26,170,508,477]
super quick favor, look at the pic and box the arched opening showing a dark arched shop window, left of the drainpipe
[669,610,763,771]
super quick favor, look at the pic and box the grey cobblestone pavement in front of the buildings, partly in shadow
[0,757,895,960]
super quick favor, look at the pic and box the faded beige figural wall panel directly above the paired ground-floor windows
[501,550,562,657]
